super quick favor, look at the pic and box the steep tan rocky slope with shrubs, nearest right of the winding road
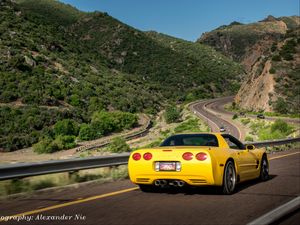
[236,29,300,114]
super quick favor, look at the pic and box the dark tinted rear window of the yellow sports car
[160,134,219,147]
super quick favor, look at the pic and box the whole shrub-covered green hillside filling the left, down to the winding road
[0,0,242,150]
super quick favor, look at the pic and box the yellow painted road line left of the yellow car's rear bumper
[0,187,138,222]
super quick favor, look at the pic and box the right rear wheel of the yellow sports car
[222,161,236,195]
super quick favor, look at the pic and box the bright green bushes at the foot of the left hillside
[33,111,138,153]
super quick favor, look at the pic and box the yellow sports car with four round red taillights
[128,133,269,194]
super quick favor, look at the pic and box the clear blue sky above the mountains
[60,0,300,41]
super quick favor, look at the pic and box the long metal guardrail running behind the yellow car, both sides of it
[0,138,300,180]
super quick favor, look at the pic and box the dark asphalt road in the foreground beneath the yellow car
[0,149,300,225]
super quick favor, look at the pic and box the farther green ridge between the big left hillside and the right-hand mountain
[146,31,244,93]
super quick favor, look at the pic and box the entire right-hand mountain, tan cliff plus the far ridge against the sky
[197,16,300,113]
